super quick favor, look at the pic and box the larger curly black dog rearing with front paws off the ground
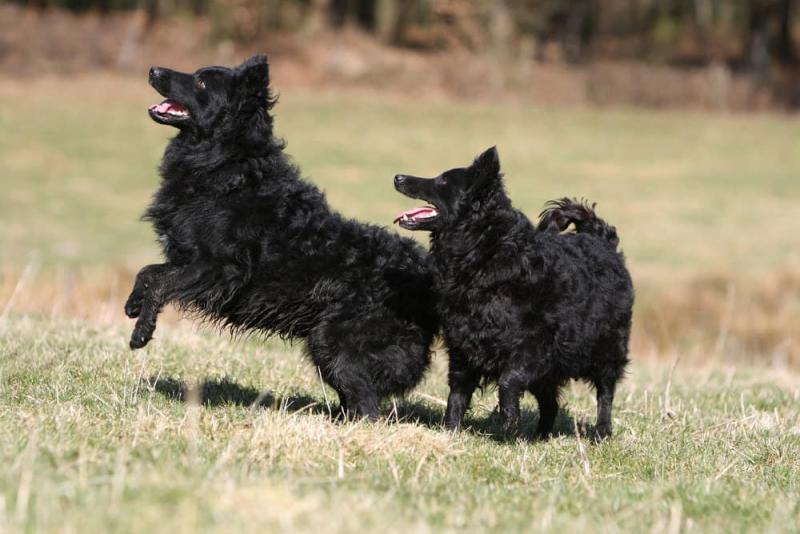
[125,56,437,419]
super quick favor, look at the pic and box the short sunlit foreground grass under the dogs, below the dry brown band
[0,316,800,532]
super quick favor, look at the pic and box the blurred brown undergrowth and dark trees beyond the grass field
[7,0,800,110]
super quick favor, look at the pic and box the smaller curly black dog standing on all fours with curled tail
[395,148,633,438]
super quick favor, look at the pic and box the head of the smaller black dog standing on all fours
[394,147,502,232]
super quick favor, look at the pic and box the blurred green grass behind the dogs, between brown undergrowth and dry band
[0,78,800,276]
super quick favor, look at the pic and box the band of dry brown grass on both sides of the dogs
[0,267,800,368]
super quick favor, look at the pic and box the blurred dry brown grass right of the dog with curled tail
[633,268,800,367]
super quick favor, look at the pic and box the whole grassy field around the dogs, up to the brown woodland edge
[0,76,800,532]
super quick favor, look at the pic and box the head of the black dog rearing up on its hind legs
[149,56,274,136]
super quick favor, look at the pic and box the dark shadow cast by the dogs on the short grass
[145,375,594,443]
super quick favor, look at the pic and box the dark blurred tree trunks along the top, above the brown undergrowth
[12,0,797,69]
